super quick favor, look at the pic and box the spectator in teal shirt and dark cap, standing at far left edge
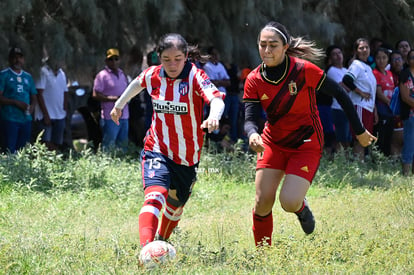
[0,47,37,153]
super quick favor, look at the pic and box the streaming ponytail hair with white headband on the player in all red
[257,21,324,61]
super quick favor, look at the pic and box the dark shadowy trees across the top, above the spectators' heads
[0,0,414,81]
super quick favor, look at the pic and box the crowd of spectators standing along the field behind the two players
[0,38,414,175]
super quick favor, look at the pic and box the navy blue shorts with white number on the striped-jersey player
[141,150,198,204]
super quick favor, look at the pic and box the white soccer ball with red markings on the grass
[139,241,177,268]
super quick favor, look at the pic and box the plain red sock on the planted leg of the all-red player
[253,210,273,246]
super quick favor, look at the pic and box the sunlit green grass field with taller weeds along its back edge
[0,145,414,274]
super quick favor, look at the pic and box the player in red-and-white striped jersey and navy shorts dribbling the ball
[111,34,224,246]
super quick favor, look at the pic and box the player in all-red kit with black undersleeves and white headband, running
[243,22,376,246]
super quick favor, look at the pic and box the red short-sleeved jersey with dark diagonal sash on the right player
[243,56,325,151]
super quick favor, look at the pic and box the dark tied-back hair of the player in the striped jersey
[157,33,208,62]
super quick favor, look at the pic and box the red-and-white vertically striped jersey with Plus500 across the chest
[137,62,224,166]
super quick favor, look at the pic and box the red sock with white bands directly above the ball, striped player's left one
[139,186,168,246]
